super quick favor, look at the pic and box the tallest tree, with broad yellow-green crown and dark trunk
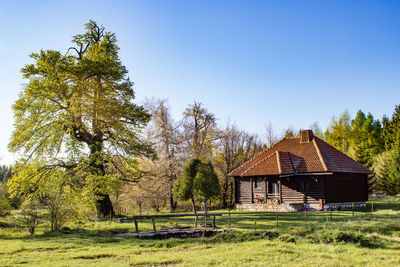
[9,21,152,218]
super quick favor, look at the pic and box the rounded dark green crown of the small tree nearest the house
[193,162,221,202]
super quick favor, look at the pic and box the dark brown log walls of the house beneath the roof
[235,173,368,204]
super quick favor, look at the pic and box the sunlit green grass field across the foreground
[0,199,400,267]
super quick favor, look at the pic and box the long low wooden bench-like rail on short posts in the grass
[120,213,222,233]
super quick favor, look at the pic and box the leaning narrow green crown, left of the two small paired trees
[174,158,201,201]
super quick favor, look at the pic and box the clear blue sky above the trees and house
[0,0,400,164]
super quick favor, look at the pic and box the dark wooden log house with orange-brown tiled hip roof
[229,130,371,211]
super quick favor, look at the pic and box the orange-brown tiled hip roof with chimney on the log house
[228,130,371,176]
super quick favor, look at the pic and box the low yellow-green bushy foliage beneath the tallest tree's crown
[8,162,98,231]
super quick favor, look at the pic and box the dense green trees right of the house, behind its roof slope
[325,105,400,195]
